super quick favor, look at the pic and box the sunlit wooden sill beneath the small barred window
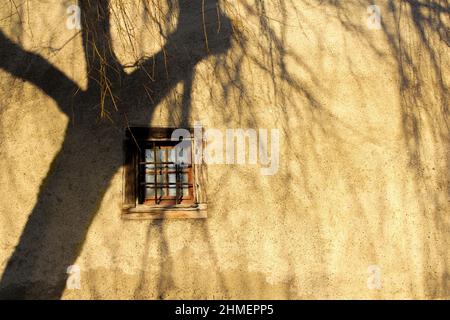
[122,204,207,220]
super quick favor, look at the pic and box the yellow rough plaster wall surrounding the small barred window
[0,0,450,299]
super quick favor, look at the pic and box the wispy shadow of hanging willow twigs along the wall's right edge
[327,0,450,298]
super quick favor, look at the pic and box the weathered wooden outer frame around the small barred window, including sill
[121,127,207,220]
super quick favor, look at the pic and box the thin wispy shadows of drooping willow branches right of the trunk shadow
[87,0,448,298]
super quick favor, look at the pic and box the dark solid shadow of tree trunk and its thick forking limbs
[0,0,231,298]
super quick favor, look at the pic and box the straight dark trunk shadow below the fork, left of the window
[1,124,121,299]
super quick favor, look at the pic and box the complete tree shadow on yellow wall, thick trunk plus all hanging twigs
[0,0,450,298]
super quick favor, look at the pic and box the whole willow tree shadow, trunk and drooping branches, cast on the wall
[0,0,448,298]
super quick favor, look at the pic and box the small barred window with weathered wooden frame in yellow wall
[122,128,206,219]
